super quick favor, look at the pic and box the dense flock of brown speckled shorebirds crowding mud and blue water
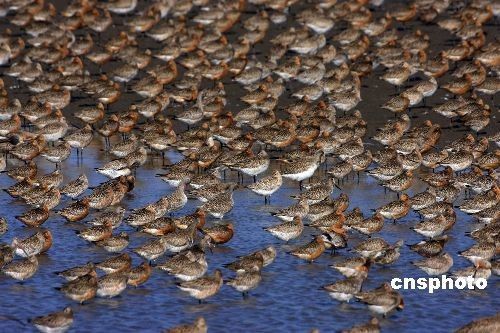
[0,0,500,332]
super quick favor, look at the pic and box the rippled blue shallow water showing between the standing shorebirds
[0,2,500,332]
